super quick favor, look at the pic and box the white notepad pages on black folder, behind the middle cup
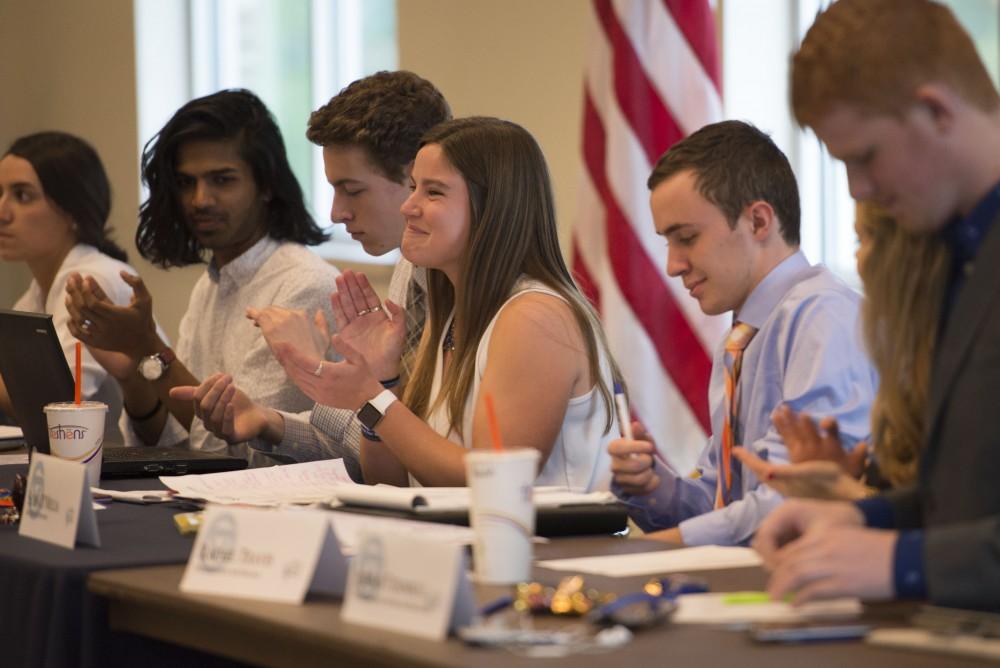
[336,485,615,513]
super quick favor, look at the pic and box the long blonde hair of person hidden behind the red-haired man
[857,204,951,486]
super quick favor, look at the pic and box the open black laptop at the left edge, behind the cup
[0,309,247,478]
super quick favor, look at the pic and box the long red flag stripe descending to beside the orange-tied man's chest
[583,91,712,433]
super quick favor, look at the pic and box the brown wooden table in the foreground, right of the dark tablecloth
[89,537,984,668]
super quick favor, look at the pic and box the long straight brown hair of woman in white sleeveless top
[403,117,620,434]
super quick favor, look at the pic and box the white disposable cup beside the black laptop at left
[45,401,108,486]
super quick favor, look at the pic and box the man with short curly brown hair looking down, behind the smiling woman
[175,71,451,479]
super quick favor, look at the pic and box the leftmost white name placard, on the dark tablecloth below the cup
[18,452,101,550]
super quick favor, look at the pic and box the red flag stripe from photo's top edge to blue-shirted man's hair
[594,0,684,164]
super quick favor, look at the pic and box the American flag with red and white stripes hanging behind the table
[573,0,727,471]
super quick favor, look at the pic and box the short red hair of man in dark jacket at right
[791,0,1000,126]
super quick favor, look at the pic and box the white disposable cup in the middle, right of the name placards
[465,448,540,584]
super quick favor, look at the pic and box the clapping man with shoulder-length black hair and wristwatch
[68,90,337,463]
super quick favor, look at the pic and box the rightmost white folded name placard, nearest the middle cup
[341,531,475,640]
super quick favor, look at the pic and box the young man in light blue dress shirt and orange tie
[609,121,878,545]
